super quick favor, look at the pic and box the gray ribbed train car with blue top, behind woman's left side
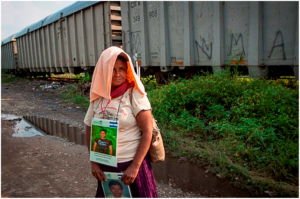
[15,1,122,75]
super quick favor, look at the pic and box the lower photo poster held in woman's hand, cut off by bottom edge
[102,172,132,198]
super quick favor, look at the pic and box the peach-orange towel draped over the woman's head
[90,46,146,102]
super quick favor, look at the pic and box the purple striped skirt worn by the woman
[96,155,158,198]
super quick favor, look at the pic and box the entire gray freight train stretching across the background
[1,1,299,82]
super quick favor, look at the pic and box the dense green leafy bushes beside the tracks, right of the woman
[148,69,299,196]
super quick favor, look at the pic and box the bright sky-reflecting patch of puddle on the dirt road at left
[1,114,45,137]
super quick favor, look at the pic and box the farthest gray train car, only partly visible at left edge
[1,35,18,72]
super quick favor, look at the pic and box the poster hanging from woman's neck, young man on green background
[90,118,119,167]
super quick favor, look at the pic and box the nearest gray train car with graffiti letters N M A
[121,1,299,79]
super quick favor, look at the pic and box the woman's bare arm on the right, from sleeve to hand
[121,110,153,185]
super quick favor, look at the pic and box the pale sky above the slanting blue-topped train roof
[1,0,76,41]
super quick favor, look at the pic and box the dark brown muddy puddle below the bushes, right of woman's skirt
[152,154,251,197]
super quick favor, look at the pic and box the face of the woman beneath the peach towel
[111,59,127,90]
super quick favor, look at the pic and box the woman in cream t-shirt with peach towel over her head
[84,47,157,198]
